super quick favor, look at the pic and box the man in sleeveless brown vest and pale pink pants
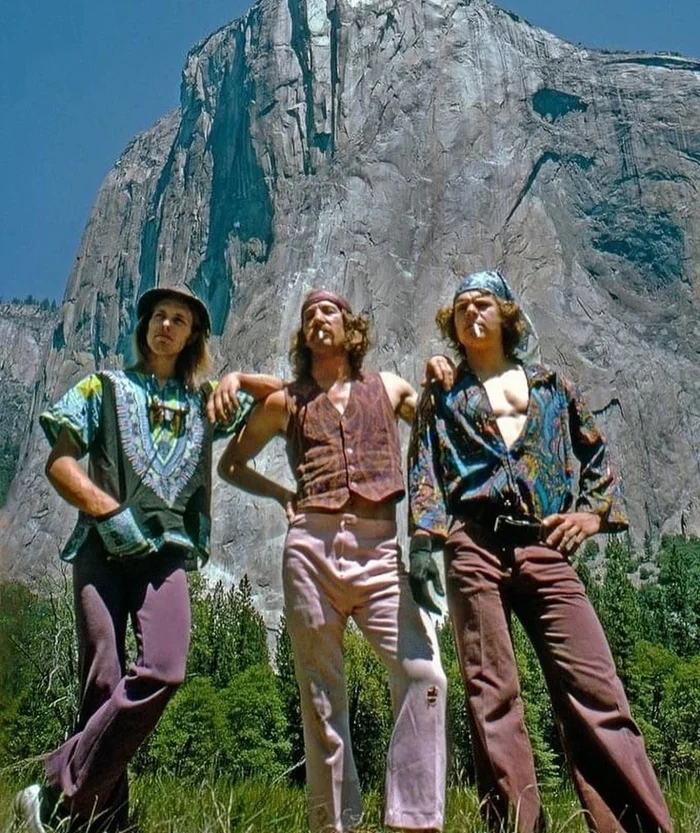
[219,290,446,831]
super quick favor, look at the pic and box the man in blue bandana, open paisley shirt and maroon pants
[409,272,672,833]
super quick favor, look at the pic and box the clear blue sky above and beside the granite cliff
[0,0,700,300]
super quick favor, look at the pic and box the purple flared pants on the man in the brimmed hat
[45,536,190,827]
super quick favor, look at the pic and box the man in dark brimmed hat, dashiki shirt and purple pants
[15,287,274,833]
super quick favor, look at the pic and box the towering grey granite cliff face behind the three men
[3,0,700,608]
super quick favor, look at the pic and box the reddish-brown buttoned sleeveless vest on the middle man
[287,373,404,511]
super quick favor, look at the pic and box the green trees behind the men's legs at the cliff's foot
[0,537,700,786]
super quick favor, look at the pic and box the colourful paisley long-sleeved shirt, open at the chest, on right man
[408,363,627,537]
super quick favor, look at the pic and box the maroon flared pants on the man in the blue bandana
[445,521,672,833]
